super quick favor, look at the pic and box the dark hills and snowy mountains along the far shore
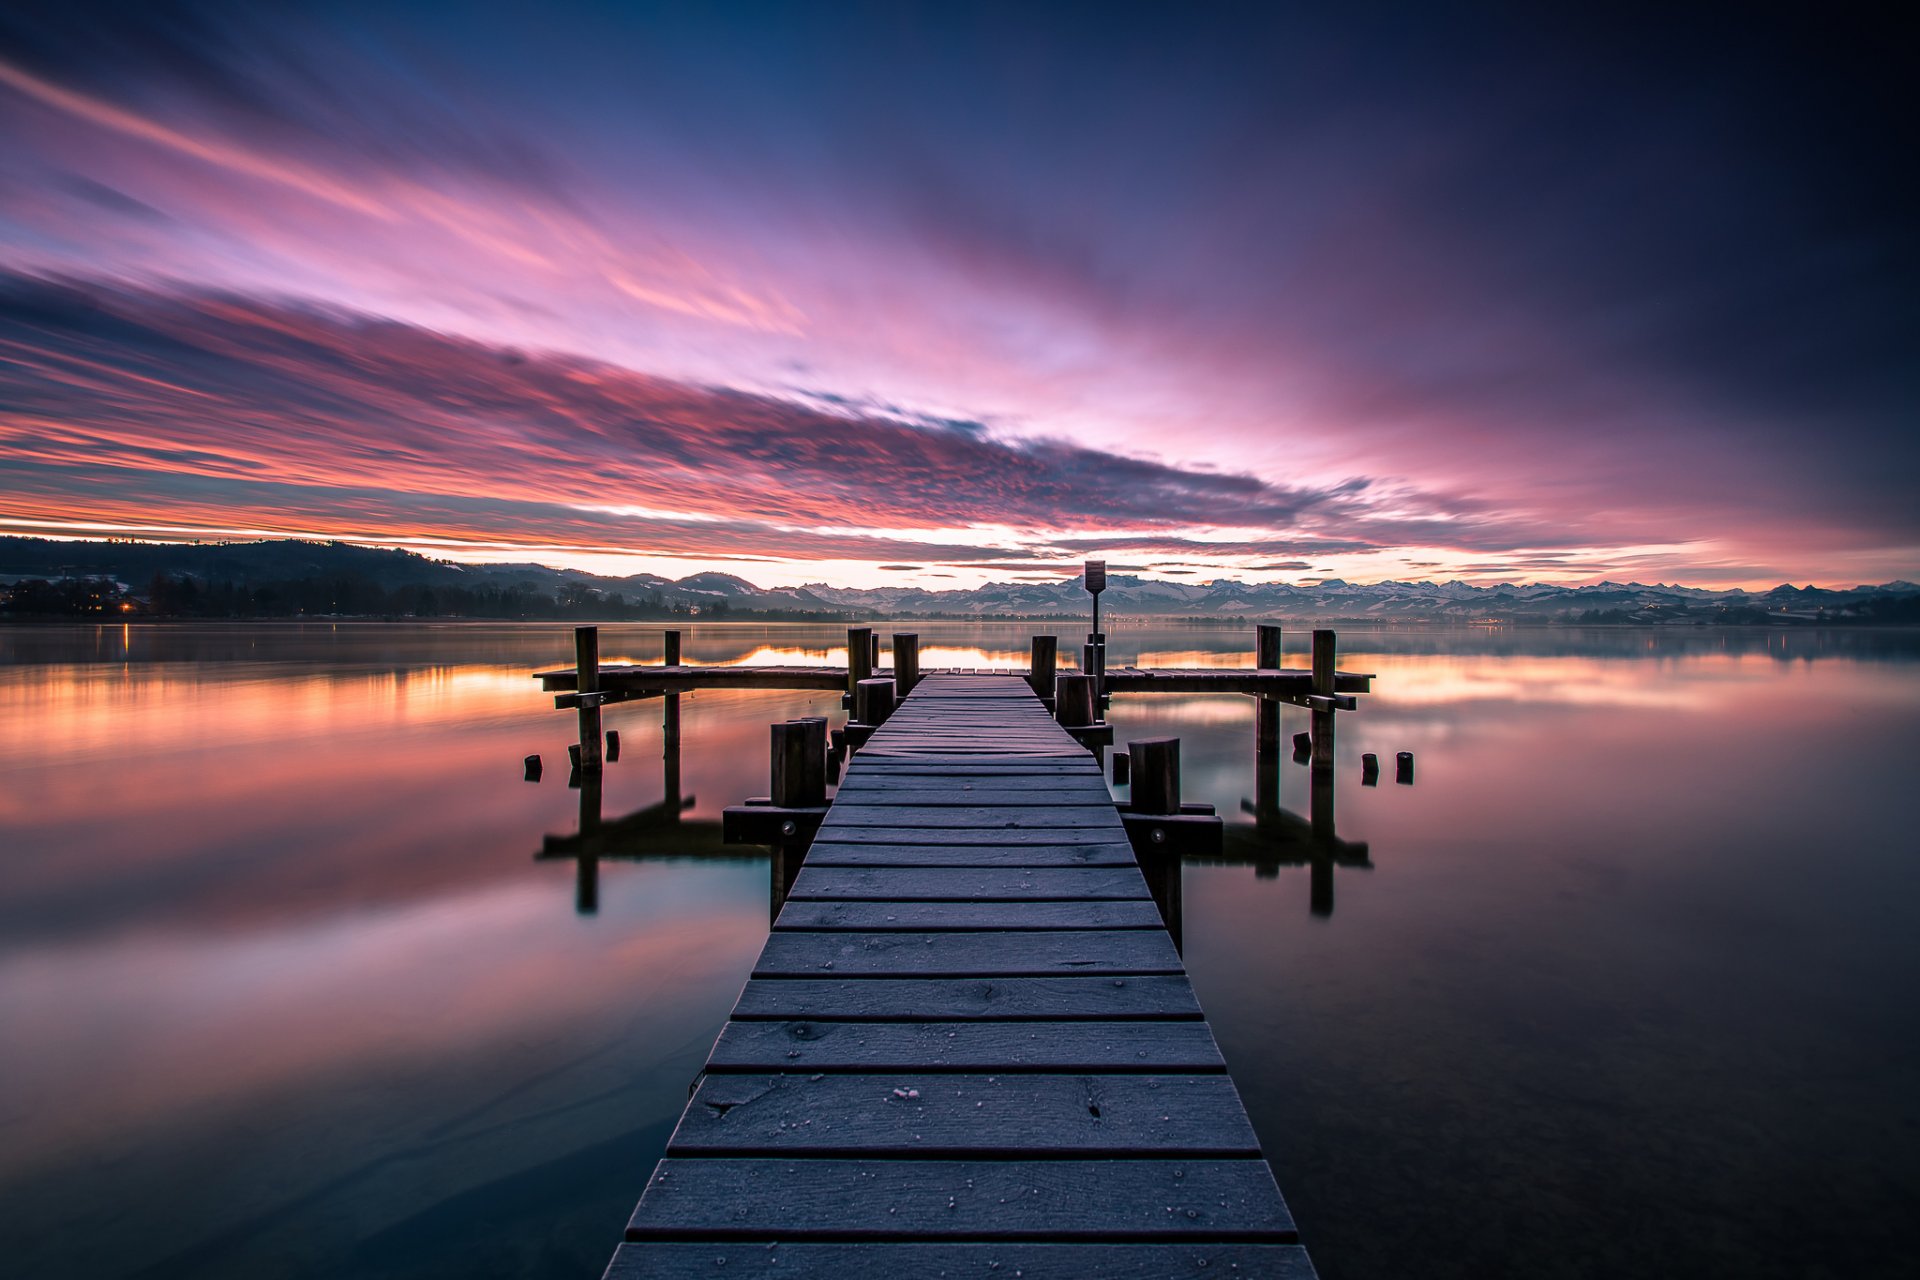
[0,537,1920,626]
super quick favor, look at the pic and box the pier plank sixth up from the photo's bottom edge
[753,929,1181,977]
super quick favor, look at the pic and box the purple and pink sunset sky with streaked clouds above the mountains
[0,0,1920,587]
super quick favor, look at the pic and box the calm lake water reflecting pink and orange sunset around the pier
[0,624,1920,1280]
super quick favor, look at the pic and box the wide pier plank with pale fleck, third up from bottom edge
[666,1071,1260,1159]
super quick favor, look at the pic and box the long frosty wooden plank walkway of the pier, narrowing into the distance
[607,676,1313,1280]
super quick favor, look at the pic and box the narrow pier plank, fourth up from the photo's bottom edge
[707,1021,1227,1075]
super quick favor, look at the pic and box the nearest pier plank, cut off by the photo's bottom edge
[603,1240,1315,1280]
